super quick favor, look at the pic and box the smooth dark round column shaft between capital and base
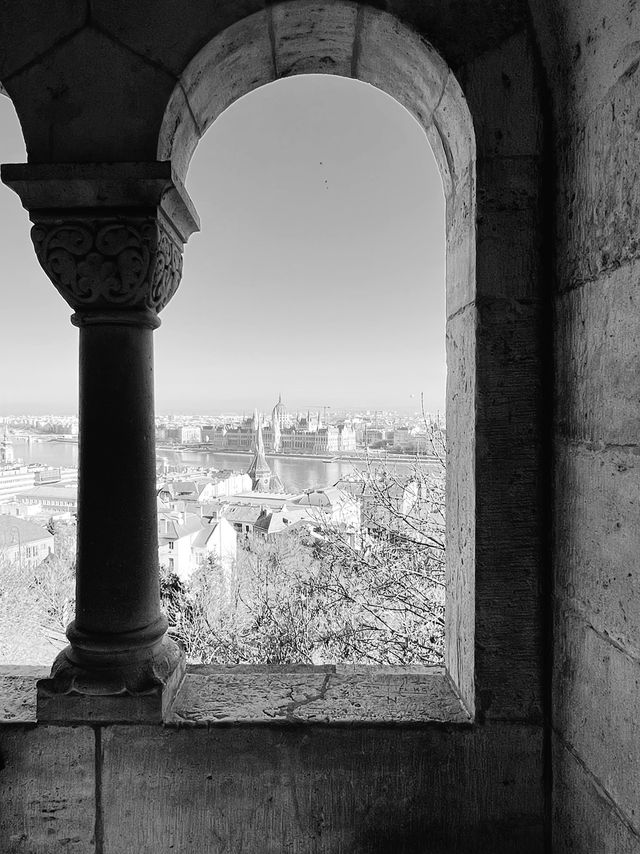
[75,317,162,634]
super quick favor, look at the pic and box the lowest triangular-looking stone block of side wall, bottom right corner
[553,736,640,854]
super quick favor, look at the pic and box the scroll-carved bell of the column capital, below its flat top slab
[31,217,182,311]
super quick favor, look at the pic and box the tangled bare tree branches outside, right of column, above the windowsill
[162,428,445,664]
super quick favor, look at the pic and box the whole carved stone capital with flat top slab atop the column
[1,162,199,313]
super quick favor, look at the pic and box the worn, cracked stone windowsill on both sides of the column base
[0,665,471,726]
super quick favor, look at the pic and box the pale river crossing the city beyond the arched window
[13,439,440,492]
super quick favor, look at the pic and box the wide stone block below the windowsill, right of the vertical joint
[102,725,542,854]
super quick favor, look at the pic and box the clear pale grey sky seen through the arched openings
[0,75,445,414]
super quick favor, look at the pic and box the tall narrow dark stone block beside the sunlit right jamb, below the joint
[475,300,544,720]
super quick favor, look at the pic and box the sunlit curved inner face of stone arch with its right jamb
[157,0,476,712]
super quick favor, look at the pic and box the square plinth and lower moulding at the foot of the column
[36,636,186,724]
